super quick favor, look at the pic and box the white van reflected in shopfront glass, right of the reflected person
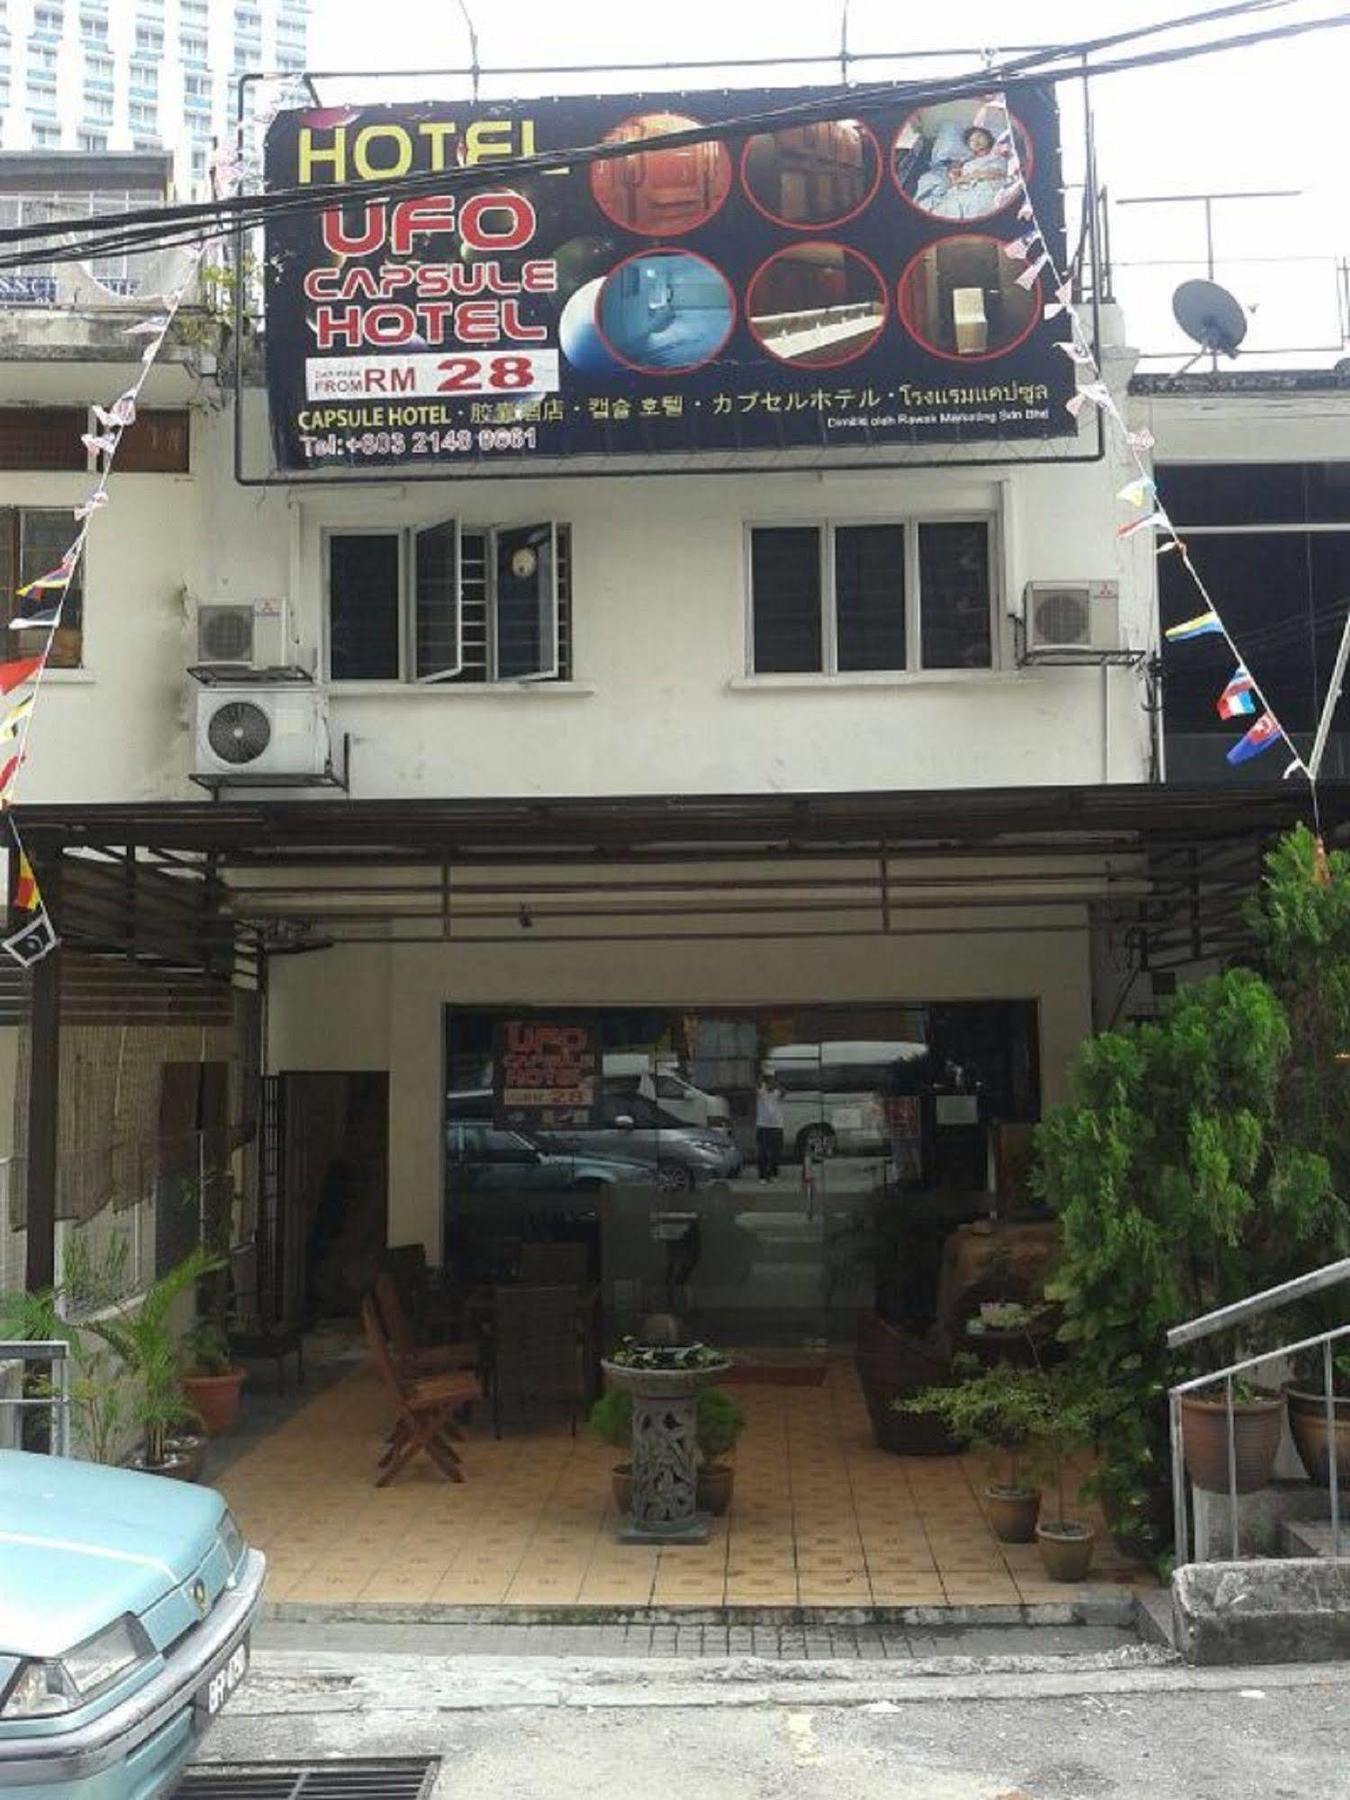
[763,1039,929,1157]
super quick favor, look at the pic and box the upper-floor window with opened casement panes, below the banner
[328,520,571,682]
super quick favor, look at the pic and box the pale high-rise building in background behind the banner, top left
[0,0,310,191]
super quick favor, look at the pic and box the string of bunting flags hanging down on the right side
[974,94,1312,783]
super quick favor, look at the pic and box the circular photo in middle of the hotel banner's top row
[740,119,882,230]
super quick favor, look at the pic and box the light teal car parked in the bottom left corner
[0,1451,266,1800]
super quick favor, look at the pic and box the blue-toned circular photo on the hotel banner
[596,250,736,374]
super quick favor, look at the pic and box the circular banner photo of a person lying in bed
[891,99,1031,220]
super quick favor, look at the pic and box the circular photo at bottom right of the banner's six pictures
[898,232,1042,362]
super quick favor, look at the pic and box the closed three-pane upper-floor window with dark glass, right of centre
[749,518,994,675]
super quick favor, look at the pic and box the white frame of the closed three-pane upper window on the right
[742,508,1003,682]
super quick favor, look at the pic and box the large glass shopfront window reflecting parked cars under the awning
[445,1001,1040,1345]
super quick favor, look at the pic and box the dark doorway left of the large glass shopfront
[281,1069,389,1327]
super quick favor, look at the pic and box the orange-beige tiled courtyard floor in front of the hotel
[220,1361,1147,1607]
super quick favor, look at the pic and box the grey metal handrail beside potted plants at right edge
[1166,1256,1350,1566]
